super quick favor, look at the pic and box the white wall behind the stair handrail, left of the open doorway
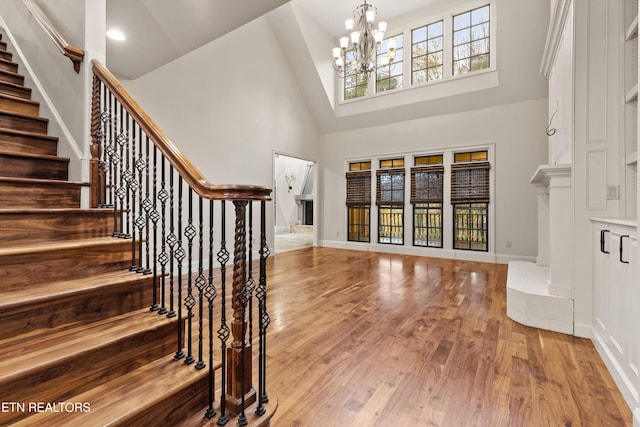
[123,18,318,251]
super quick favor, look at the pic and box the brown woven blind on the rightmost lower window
[451,162,491,203]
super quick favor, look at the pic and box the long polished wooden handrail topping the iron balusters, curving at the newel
[91,59,271,204]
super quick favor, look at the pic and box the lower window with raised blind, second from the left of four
[376,159,405,245]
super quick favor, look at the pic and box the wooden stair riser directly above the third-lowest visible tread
[0,240,131,291]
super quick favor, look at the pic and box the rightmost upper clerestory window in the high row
[453,5,490,76]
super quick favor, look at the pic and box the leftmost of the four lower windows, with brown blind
[345,162,371,242]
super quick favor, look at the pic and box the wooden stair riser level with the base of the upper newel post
[0,181,80,209]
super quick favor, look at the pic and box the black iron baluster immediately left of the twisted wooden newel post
[218,200,230,426]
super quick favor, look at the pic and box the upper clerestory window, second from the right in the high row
[411,21,444,85]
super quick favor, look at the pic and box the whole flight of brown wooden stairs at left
[0,32,215,426]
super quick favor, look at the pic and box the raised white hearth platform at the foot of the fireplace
[507,261,573,334]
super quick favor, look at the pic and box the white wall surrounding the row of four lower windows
[320,98,547,260]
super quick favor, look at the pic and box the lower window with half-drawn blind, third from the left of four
[410,162,444,248]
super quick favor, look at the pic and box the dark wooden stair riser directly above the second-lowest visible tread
[0,273,153,340]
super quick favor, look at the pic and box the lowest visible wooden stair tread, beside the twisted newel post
[14,354,222,426]
